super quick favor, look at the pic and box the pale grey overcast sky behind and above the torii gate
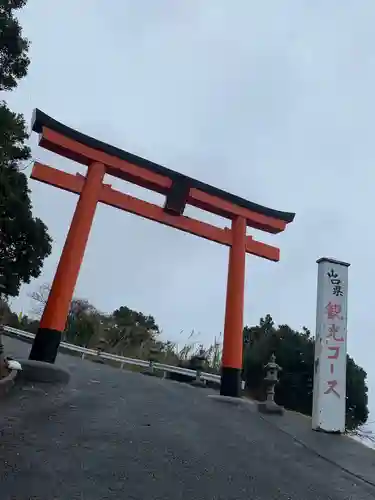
[7,0,375,418]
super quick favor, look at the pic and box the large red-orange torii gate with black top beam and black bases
[30,109,295,396]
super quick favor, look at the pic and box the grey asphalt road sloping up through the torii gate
[0,338,375,500]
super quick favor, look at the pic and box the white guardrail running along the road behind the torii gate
[3,325,220,384]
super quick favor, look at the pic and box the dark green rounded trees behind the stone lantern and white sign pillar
[244,315,368,429]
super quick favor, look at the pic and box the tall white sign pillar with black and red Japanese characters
[312,257,350,433]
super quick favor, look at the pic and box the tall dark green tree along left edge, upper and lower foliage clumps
[0,0,51,296]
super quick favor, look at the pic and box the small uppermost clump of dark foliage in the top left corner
[0,0,30,91]
